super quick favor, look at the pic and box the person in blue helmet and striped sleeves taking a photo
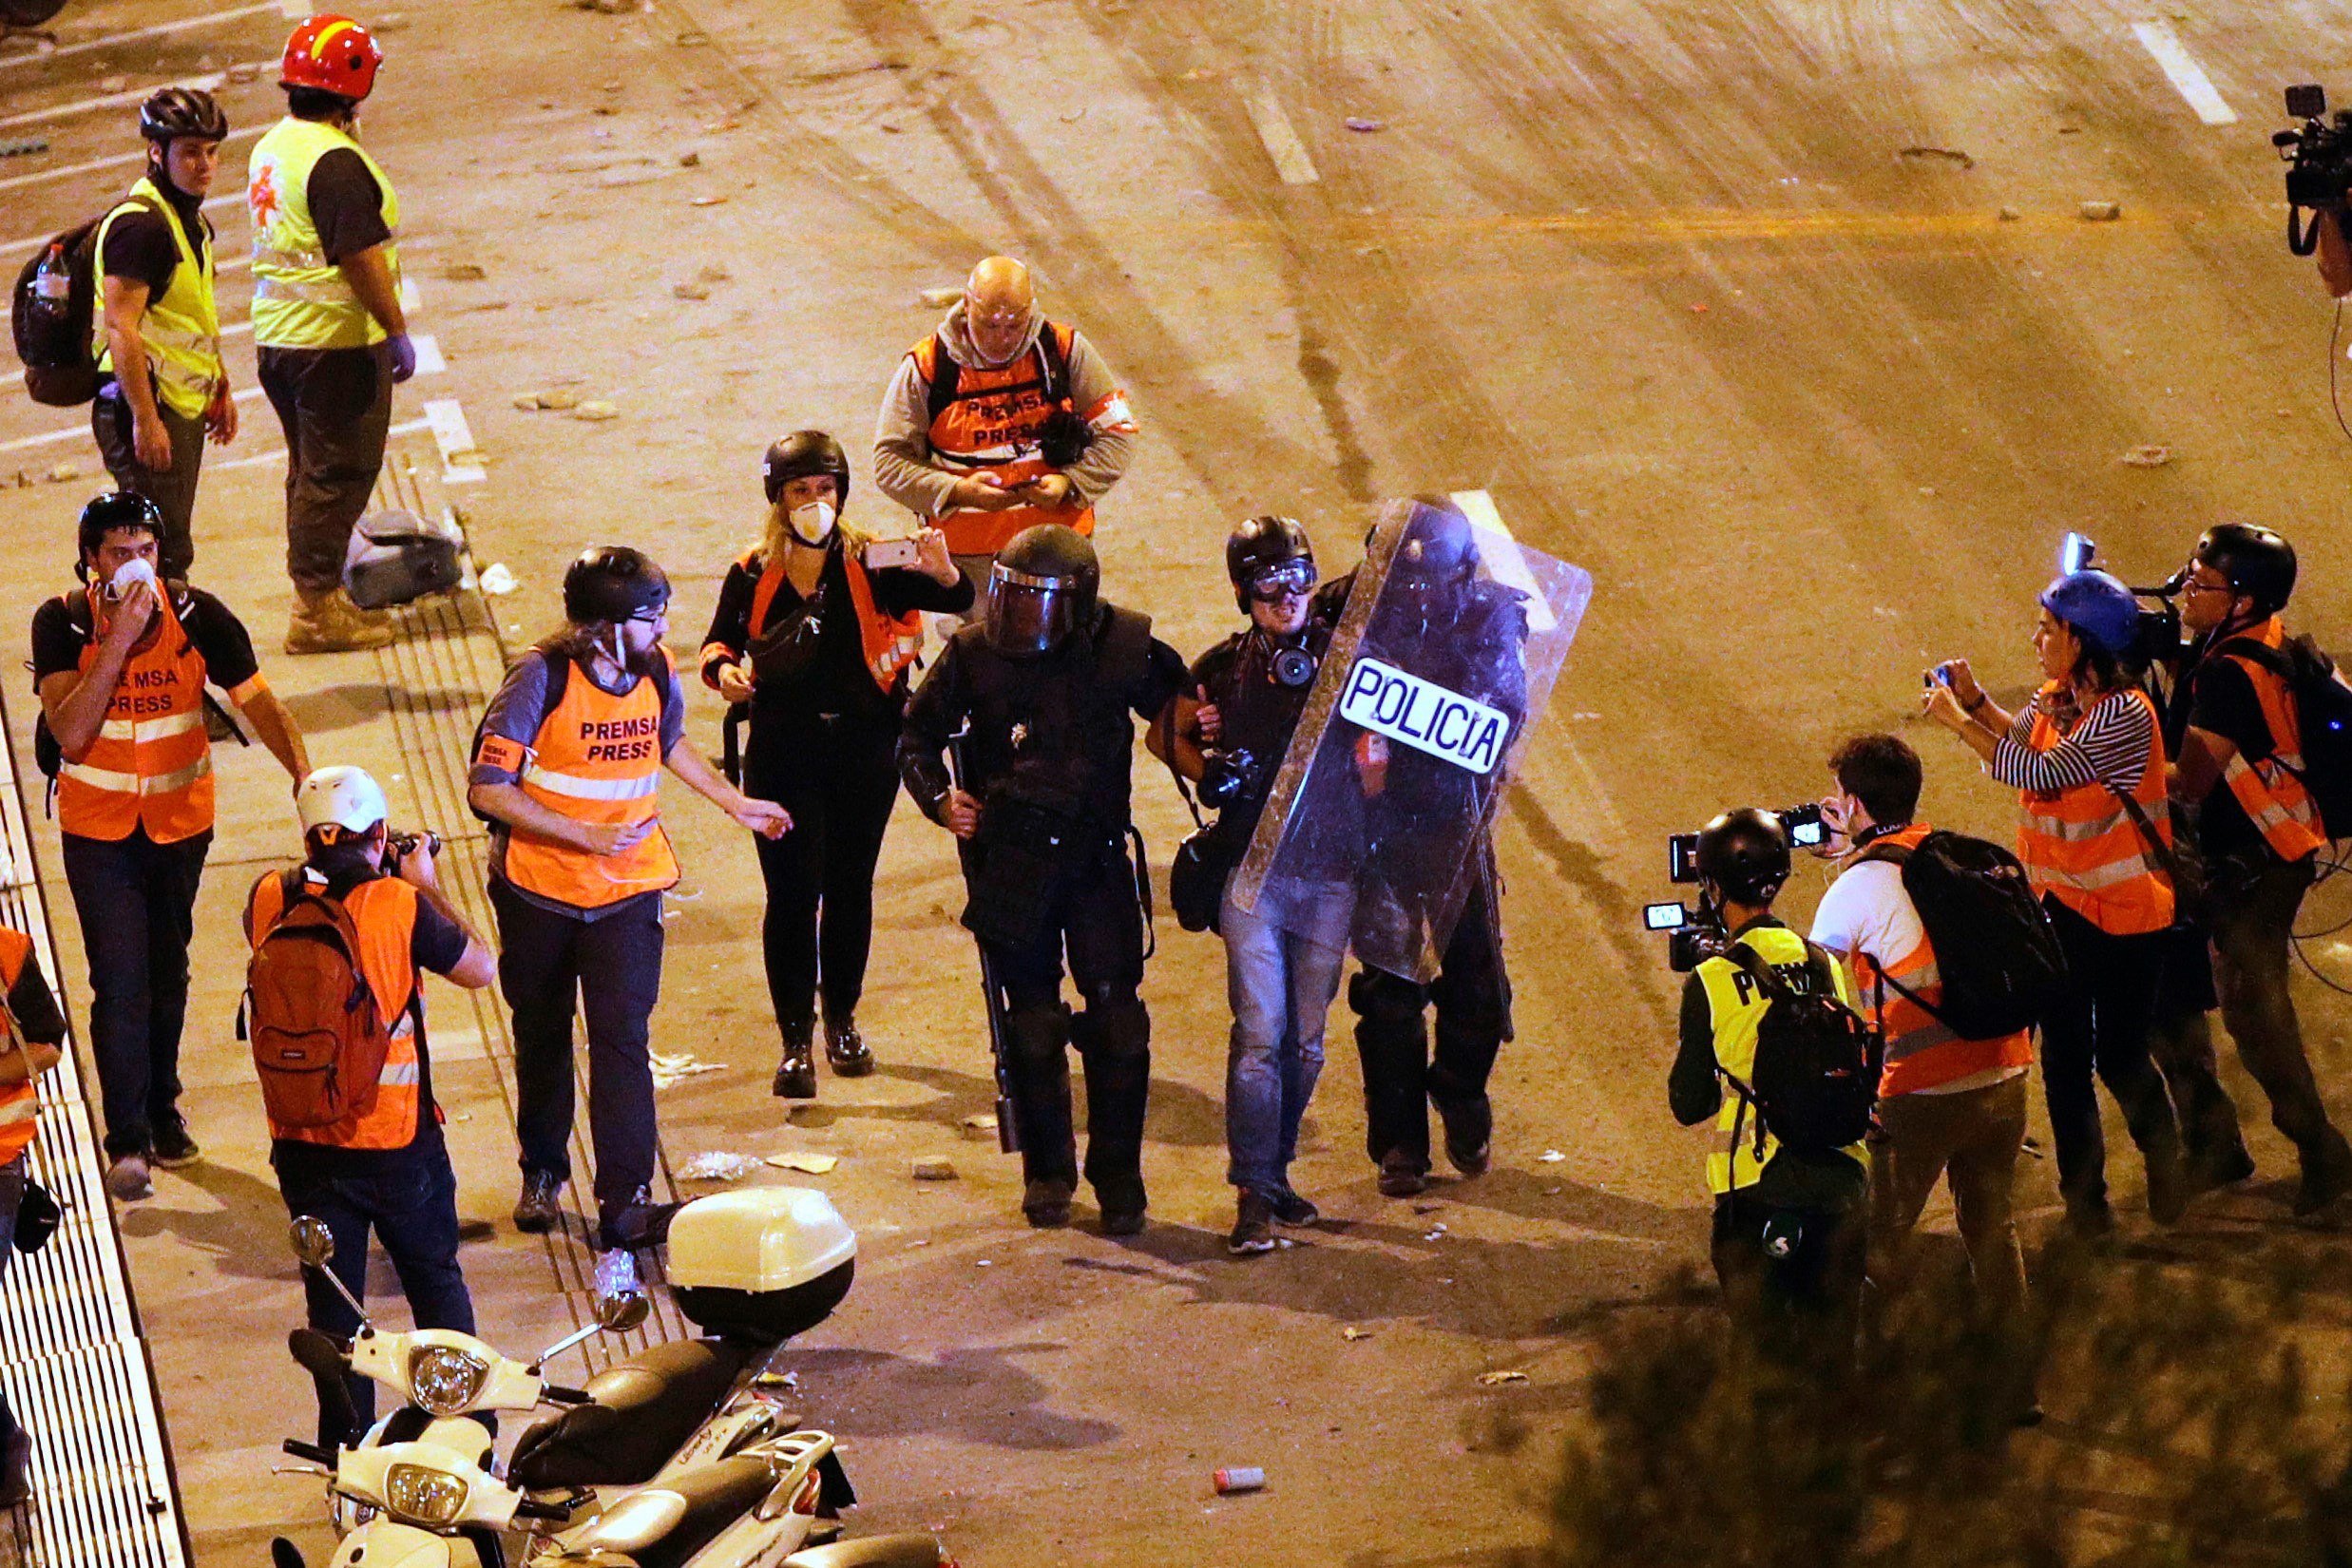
[1922,571,2188,1236]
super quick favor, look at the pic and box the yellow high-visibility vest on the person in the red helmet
[244,115,400,348]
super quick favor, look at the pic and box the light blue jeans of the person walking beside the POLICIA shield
[1216,877,1355,1192]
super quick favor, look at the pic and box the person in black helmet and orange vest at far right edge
[2166,522,2352,1215]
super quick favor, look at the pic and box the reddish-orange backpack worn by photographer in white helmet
[244,870,392,1128]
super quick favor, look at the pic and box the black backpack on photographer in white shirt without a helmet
[1863,830,2065,1039]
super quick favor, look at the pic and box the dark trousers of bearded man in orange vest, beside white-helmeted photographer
[489,877,663,1249]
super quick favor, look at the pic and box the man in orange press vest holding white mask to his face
[33,491,311,1204]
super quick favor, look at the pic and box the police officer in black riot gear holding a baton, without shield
[898,525,1190,1236]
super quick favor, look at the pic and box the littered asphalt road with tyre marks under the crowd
[0,0,2352,1568]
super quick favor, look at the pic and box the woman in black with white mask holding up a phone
[701,430,971,1100]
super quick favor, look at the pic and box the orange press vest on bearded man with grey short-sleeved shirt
[506,654,678,909]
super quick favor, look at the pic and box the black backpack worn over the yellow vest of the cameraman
[1717,943,1886,1159]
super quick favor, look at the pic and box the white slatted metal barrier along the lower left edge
[0,696,193,1568]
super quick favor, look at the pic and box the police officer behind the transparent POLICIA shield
[1324,498,1526,1196]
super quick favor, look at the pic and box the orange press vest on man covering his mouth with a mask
[56,587,212,844]
